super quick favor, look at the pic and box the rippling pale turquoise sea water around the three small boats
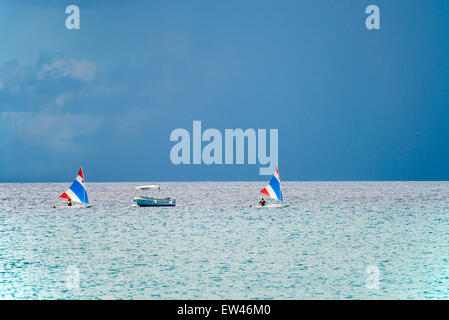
[0,182,449,299]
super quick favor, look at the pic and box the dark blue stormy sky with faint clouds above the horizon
[0,0,449,182]
